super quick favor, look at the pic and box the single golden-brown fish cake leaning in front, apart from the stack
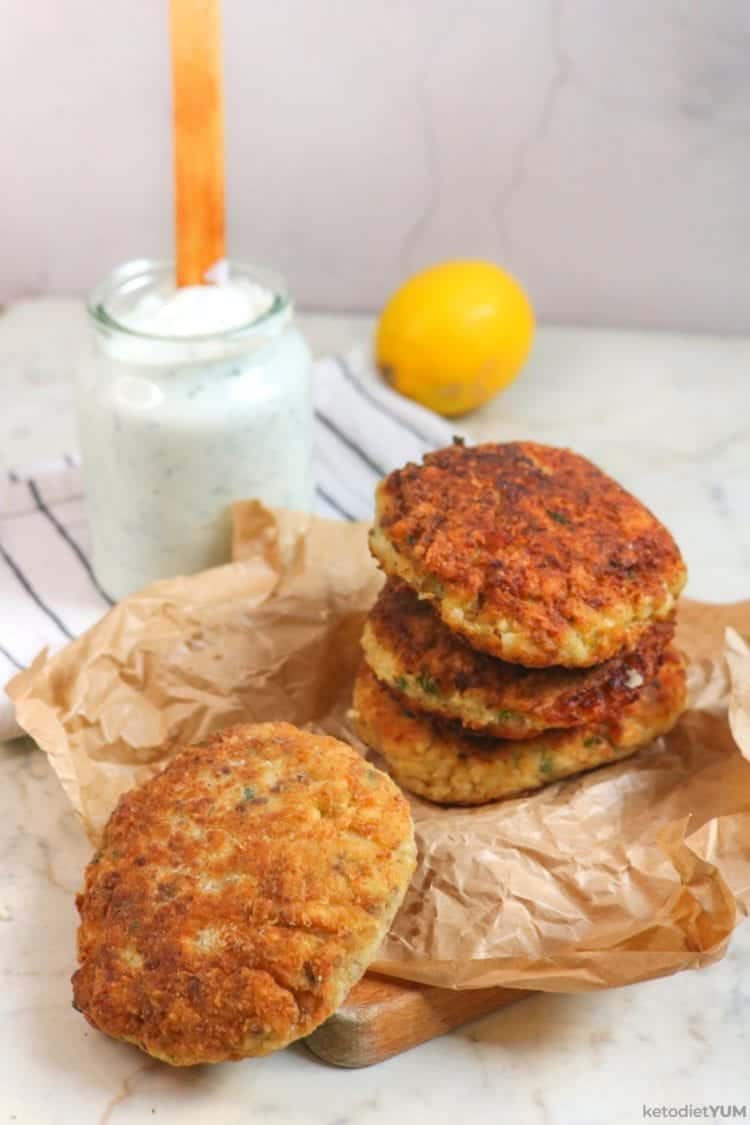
[73,722,415,1065]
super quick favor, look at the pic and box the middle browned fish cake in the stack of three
[362,578,675,738]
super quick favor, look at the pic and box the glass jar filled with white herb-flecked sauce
[76,260,314,599]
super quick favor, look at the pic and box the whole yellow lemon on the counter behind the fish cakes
[376,261,534,415]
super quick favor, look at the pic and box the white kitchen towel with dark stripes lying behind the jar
[0,350,455,739]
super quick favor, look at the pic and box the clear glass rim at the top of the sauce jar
[85,258,293,344]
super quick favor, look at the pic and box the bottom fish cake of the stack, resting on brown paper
[353,645,685,804]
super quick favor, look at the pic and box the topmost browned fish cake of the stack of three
[370,442,686,667]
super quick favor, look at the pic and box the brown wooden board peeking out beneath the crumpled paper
[305,973,528,1067]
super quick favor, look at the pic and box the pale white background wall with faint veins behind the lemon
[0,0,750,331]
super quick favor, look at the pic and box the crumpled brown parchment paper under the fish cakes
[8,503,750,992]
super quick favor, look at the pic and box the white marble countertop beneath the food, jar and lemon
[0,299,750,1125]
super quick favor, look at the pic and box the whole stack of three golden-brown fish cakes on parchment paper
[354,442,686,804]
